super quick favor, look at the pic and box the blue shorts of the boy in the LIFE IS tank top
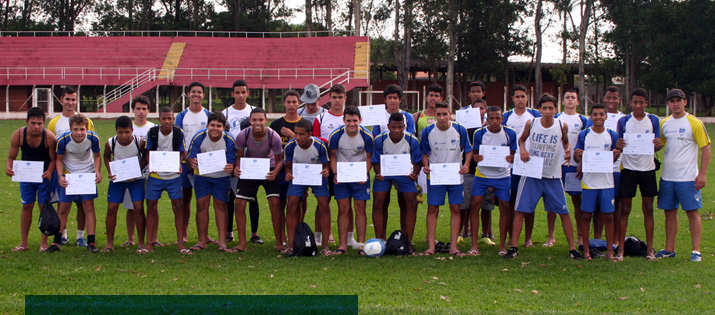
[515,177,569,214]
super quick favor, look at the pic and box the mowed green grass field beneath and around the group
[0,120,715,314]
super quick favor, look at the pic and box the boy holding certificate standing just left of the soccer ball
[328,106,374,254]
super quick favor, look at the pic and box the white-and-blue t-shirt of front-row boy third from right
[577,128,615,189]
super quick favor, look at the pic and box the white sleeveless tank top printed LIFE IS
[527,117,563,178]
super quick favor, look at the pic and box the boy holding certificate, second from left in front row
[46,115,102,253]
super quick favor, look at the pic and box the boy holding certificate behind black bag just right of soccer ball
[372,113,422,242]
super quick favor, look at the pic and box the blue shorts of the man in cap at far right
[658,179,703,211]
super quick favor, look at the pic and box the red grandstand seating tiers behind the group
[0,37,369,111]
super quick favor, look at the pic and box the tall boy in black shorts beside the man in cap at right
[616,88,663,260]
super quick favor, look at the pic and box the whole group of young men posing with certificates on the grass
[6,80,710,261]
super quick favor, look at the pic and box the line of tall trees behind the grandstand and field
[0,0,715,111]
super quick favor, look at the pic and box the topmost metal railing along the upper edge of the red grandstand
[0,30,356,38]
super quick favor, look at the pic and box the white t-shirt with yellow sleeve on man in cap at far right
[660,114,710,182]
